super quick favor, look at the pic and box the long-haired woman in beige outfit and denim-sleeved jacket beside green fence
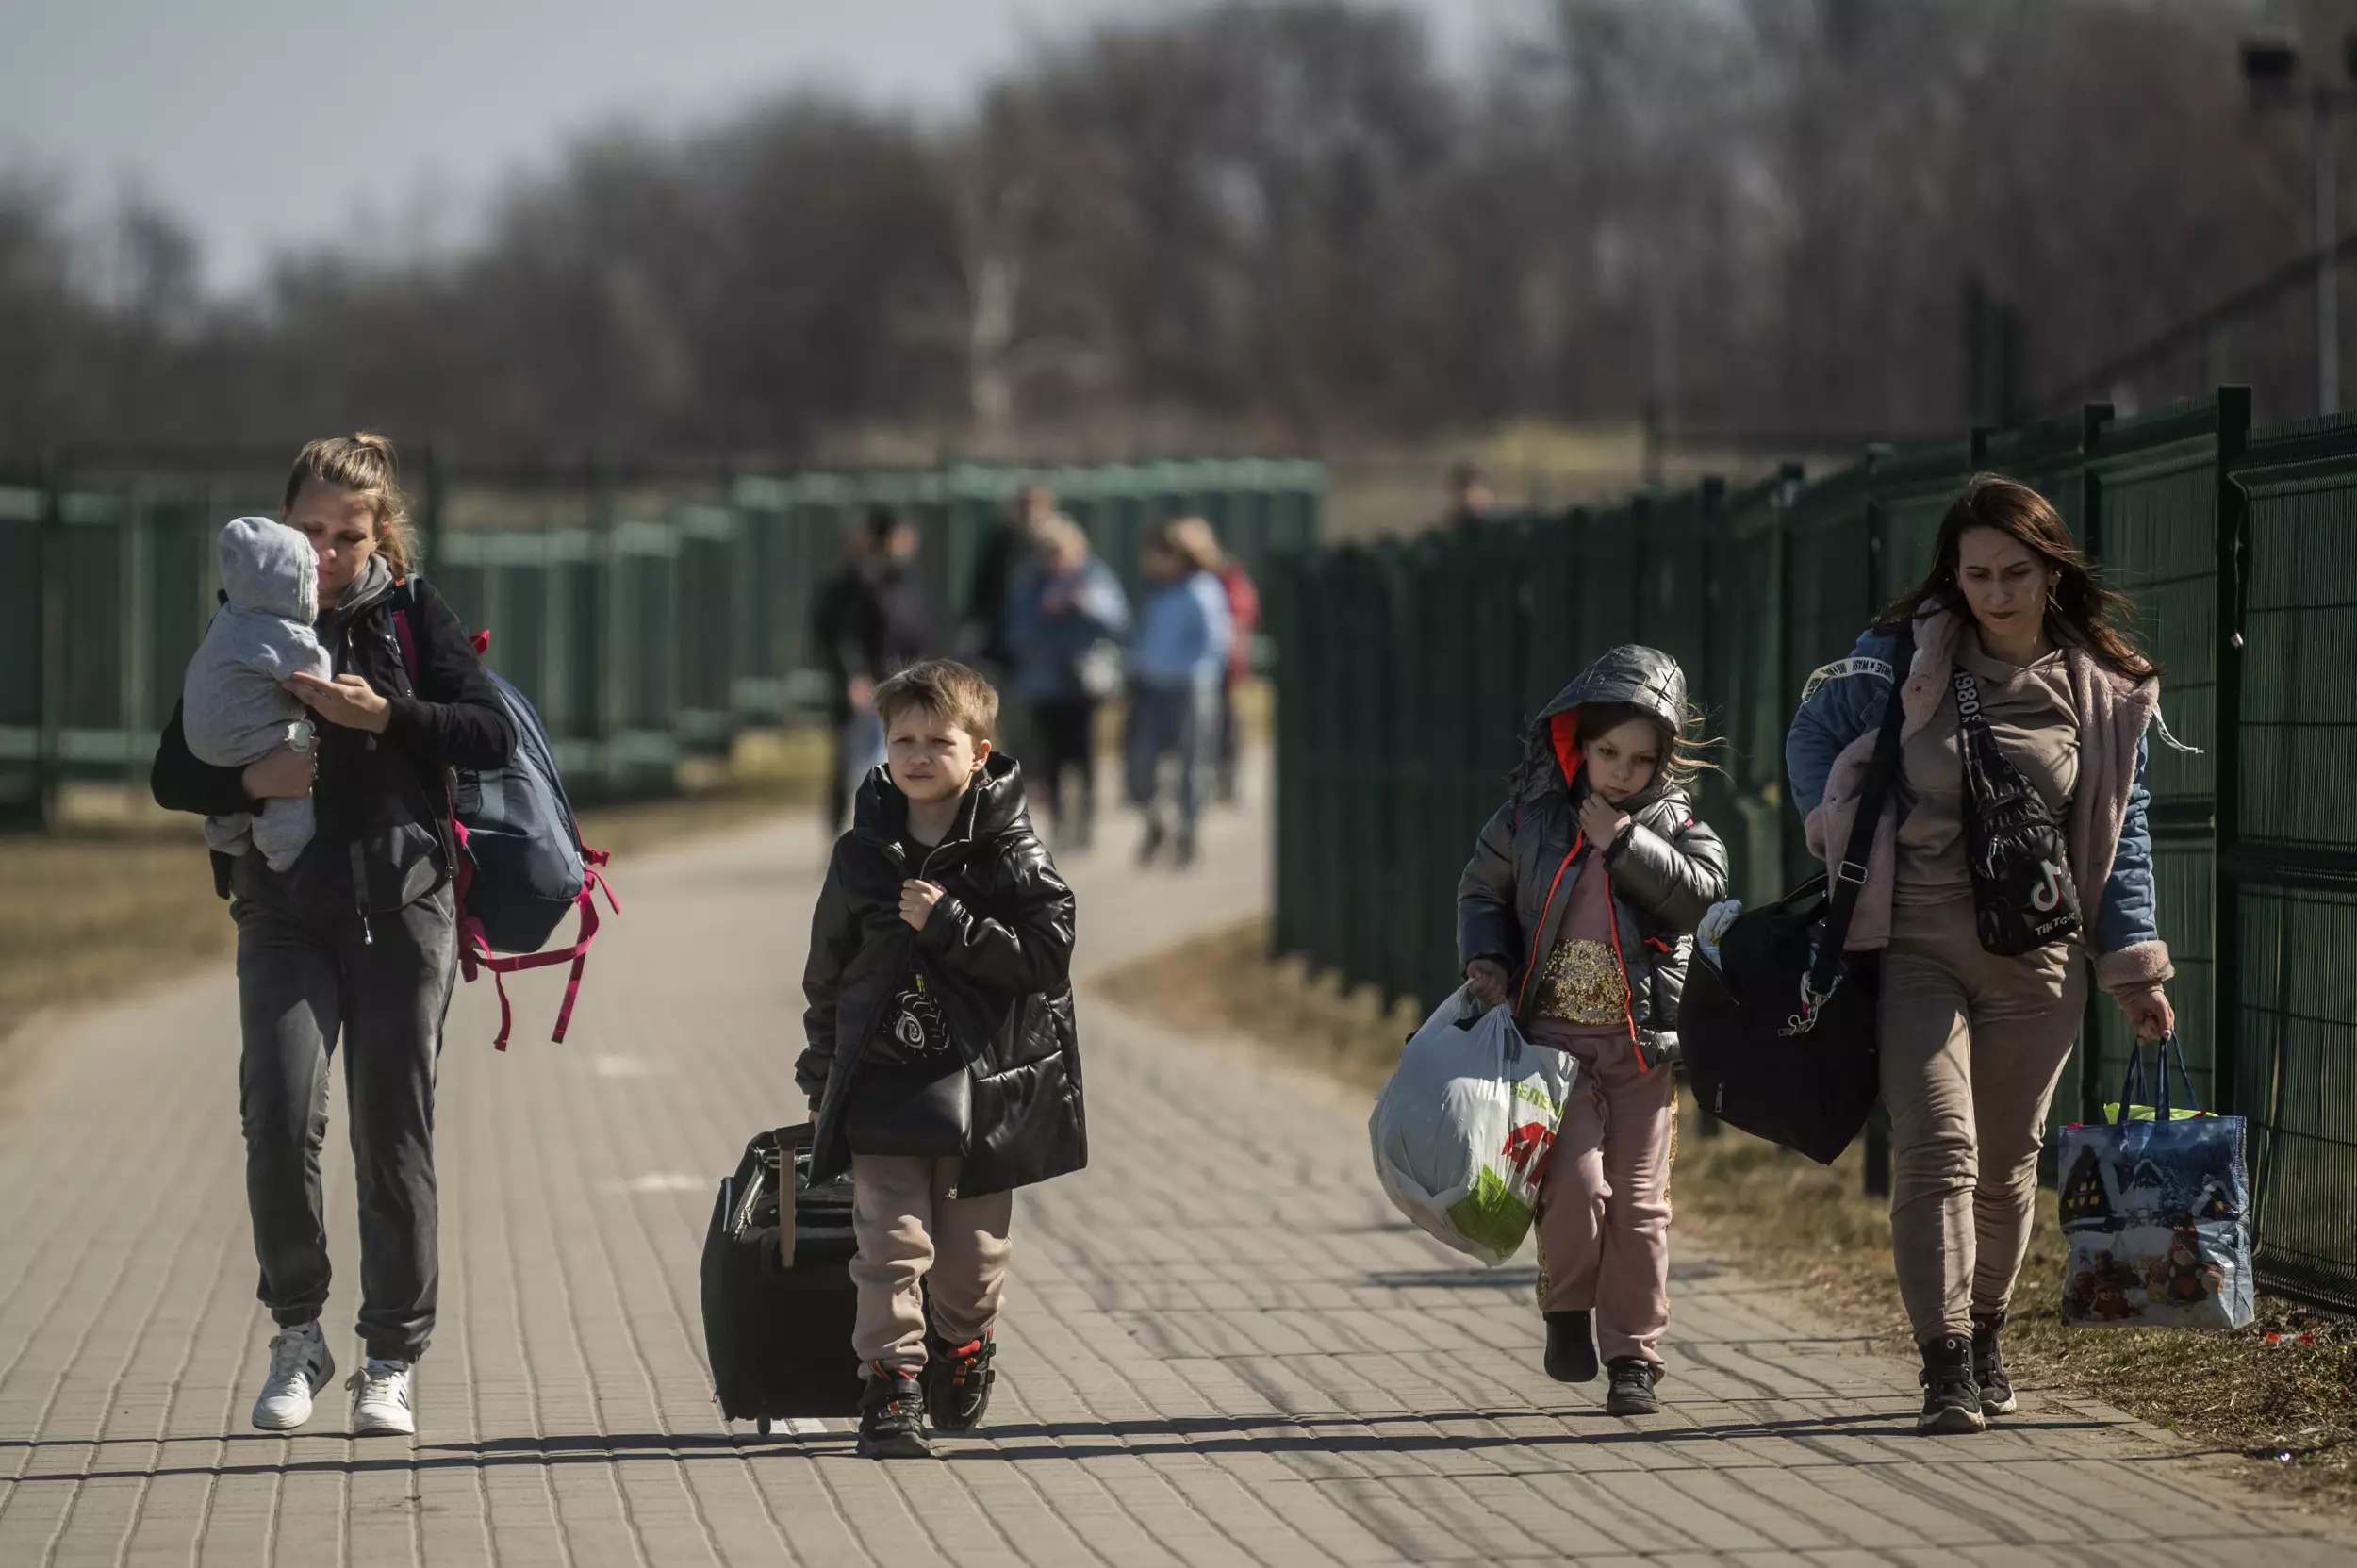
[1785,474,2176,1433]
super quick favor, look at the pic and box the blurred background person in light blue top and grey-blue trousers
[1125,523,1235,867]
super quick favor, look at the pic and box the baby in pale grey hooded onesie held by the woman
[179,517,335,870]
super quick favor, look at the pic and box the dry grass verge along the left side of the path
[0,731,828,1094]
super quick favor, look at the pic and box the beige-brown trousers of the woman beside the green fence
[1879,894,2086,1344]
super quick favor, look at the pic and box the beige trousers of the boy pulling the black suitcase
[851,1155,1016,1372]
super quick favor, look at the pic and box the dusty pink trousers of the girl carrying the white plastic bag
[1530,1021,1676,1375]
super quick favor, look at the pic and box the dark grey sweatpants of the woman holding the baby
[229,856,457,1361]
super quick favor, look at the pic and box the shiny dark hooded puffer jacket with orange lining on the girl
[1457,644,1728,1061]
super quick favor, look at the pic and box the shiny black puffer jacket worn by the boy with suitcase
[795,757,1089,1197]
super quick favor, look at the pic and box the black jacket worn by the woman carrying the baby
[149,556,517,919]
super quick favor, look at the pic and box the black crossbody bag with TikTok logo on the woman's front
[1950,665,2079,957]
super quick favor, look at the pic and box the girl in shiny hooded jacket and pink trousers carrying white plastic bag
[1457,644,1728,1414]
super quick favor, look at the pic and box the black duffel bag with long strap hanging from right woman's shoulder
[1678,636,1914,1164]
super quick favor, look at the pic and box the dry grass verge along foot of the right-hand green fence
[1098,919,2357,1513]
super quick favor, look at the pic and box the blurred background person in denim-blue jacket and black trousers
[1007,517,1129,849]
